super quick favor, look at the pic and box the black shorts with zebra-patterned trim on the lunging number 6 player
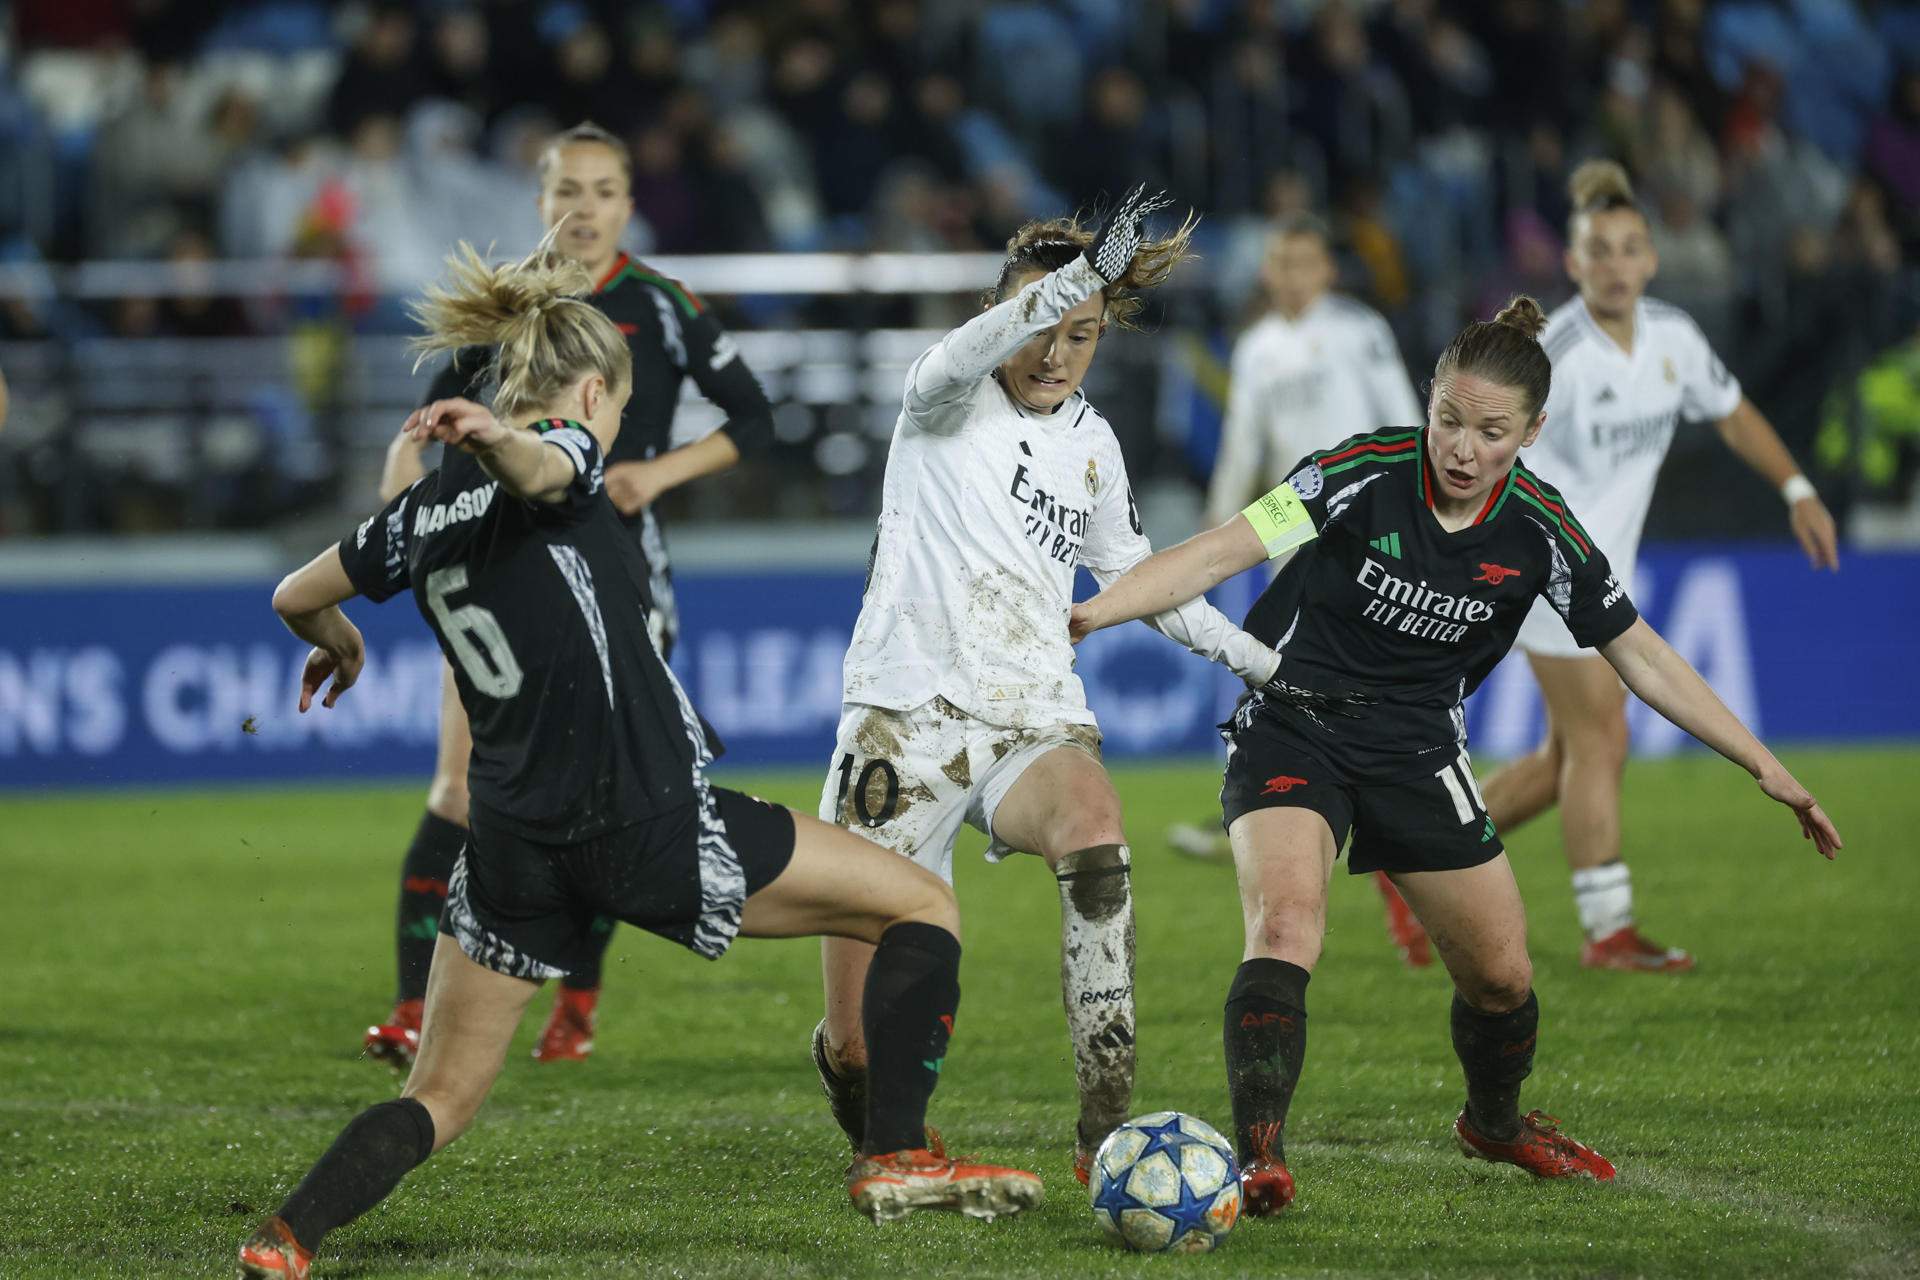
[440,785,793,979]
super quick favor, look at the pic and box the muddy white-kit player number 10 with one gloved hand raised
[814,192,1279,1182]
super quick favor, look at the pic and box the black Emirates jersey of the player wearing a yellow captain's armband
[1242,430,1640,781]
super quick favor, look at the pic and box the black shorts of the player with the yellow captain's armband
[1219,716,1505,875]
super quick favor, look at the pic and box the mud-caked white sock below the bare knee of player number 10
[1054,844,1133,1144]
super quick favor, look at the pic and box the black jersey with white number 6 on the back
[340,422,708,844]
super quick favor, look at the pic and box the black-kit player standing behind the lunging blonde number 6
[365,125,774,1069]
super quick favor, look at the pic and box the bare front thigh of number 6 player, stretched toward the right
[739,814,960,942]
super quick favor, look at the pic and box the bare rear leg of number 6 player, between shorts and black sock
[401,935,540,1151]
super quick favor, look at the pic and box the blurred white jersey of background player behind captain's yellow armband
[1206,294,1427,524]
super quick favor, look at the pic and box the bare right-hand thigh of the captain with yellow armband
[1388,854,1534,1011]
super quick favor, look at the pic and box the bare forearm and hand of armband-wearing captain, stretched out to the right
[1599,618,1841,858]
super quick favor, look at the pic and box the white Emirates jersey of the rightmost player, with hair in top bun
[1526,296,1740,574]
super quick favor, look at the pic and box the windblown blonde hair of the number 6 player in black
[407,223,634,420]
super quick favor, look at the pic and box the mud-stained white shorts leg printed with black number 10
[820,700,972,883]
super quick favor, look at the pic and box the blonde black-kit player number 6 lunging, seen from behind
[240,232,1041,1280]
